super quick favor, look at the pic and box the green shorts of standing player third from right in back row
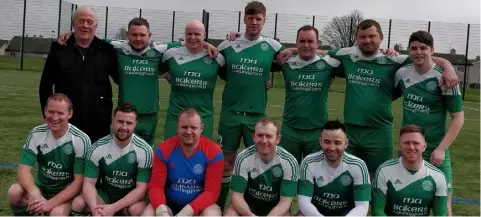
[279,123,322,164]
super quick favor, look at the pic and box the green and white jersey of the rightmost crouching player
[372,157,448,216]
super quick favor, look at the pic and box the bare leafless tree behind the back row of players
[321,10,364,49]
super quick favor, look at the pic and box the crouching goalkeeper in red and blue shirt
[142,108,224,216]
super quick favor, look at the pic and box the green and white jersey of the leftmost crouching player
[20,124,90,195]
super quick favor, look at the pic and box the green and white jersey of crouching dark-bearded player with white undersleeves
[299,152,371,216]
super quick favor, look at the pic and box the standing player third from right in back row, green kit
[273,25,342,163]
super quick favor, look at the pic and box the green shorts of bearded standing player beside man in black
[135,112,159,146]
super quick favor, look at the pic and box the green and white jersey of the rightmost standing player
[395,63,463,153]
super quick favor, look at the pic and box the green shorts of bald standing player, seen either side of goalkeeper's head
[162,115,214,141]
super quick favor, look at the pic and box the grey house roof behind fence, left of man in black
[5,36,53,54]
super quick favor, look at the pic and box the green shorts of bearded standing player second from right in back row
[345,124,393,174]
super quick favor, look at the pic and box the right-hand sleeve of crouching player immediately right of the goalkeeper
[279,152,299,197]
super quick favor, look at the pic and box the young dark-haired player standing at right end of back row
[395,31,464,216]
